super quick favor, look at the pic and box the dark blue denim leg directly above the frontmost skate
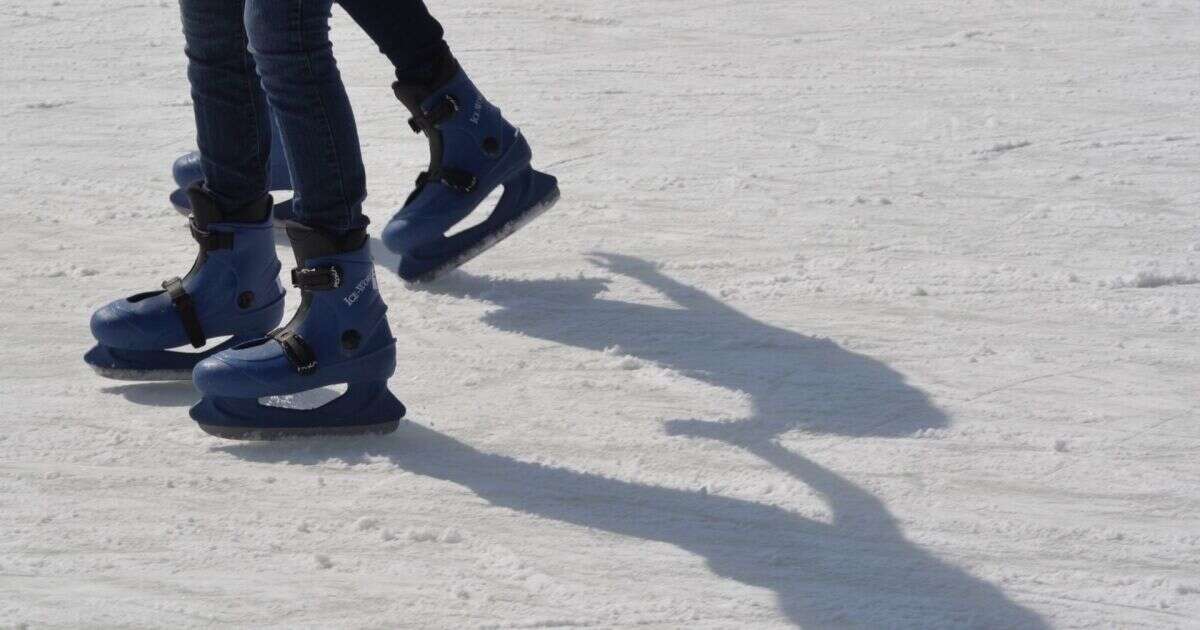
[245,0,367,232]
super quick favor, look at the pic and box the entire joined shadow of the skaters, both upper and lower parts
[221,254,1045,629]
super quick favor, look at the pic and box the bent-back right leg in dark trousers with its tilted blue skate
[326,0,558,281]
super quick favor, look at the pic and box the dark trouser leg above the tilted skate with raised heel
[337,0,449,83]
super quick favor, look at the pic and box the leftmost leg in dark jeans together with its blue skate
[84,0,283,380]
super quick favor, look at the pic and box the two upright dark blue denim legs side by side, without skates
[180,0,367,232]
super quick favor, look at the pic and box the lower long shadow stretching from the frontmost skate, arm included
[217,422,1045,630]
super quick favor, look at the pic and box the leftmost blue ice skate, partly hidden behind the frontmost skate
[84,185,283,380]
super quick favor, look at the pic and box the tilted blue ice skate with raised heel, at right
[382,59,559,282]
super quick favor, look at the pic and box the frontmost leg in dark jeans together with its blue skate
[191,0,404,438]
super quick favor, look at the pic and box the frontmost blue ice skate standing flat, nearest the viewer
[191,223,404,439]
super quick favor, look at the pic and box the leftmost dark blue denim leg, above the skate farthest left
[179,0,270,208]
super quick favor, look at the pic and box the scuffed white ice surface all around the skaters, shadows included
[0,0,1200,629]
